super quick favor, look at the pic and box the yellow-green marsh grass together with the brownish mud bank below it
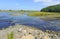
[27,12,60,20]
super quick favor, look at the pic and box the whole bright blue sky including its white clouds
[0,0,60,10]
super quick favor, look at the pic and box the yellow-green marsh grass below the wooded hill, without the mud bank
[28,12,60,17]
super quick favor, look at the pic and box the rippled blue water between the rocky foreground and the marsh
[0,12,60,31]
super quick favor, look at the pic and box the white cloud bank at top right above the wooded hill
[34,0,60,6]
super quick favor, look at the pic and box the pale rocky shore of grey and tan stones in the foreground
[0,25,60,39]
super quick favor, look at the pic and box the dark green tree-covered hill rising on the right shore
[41,4,60,12]
